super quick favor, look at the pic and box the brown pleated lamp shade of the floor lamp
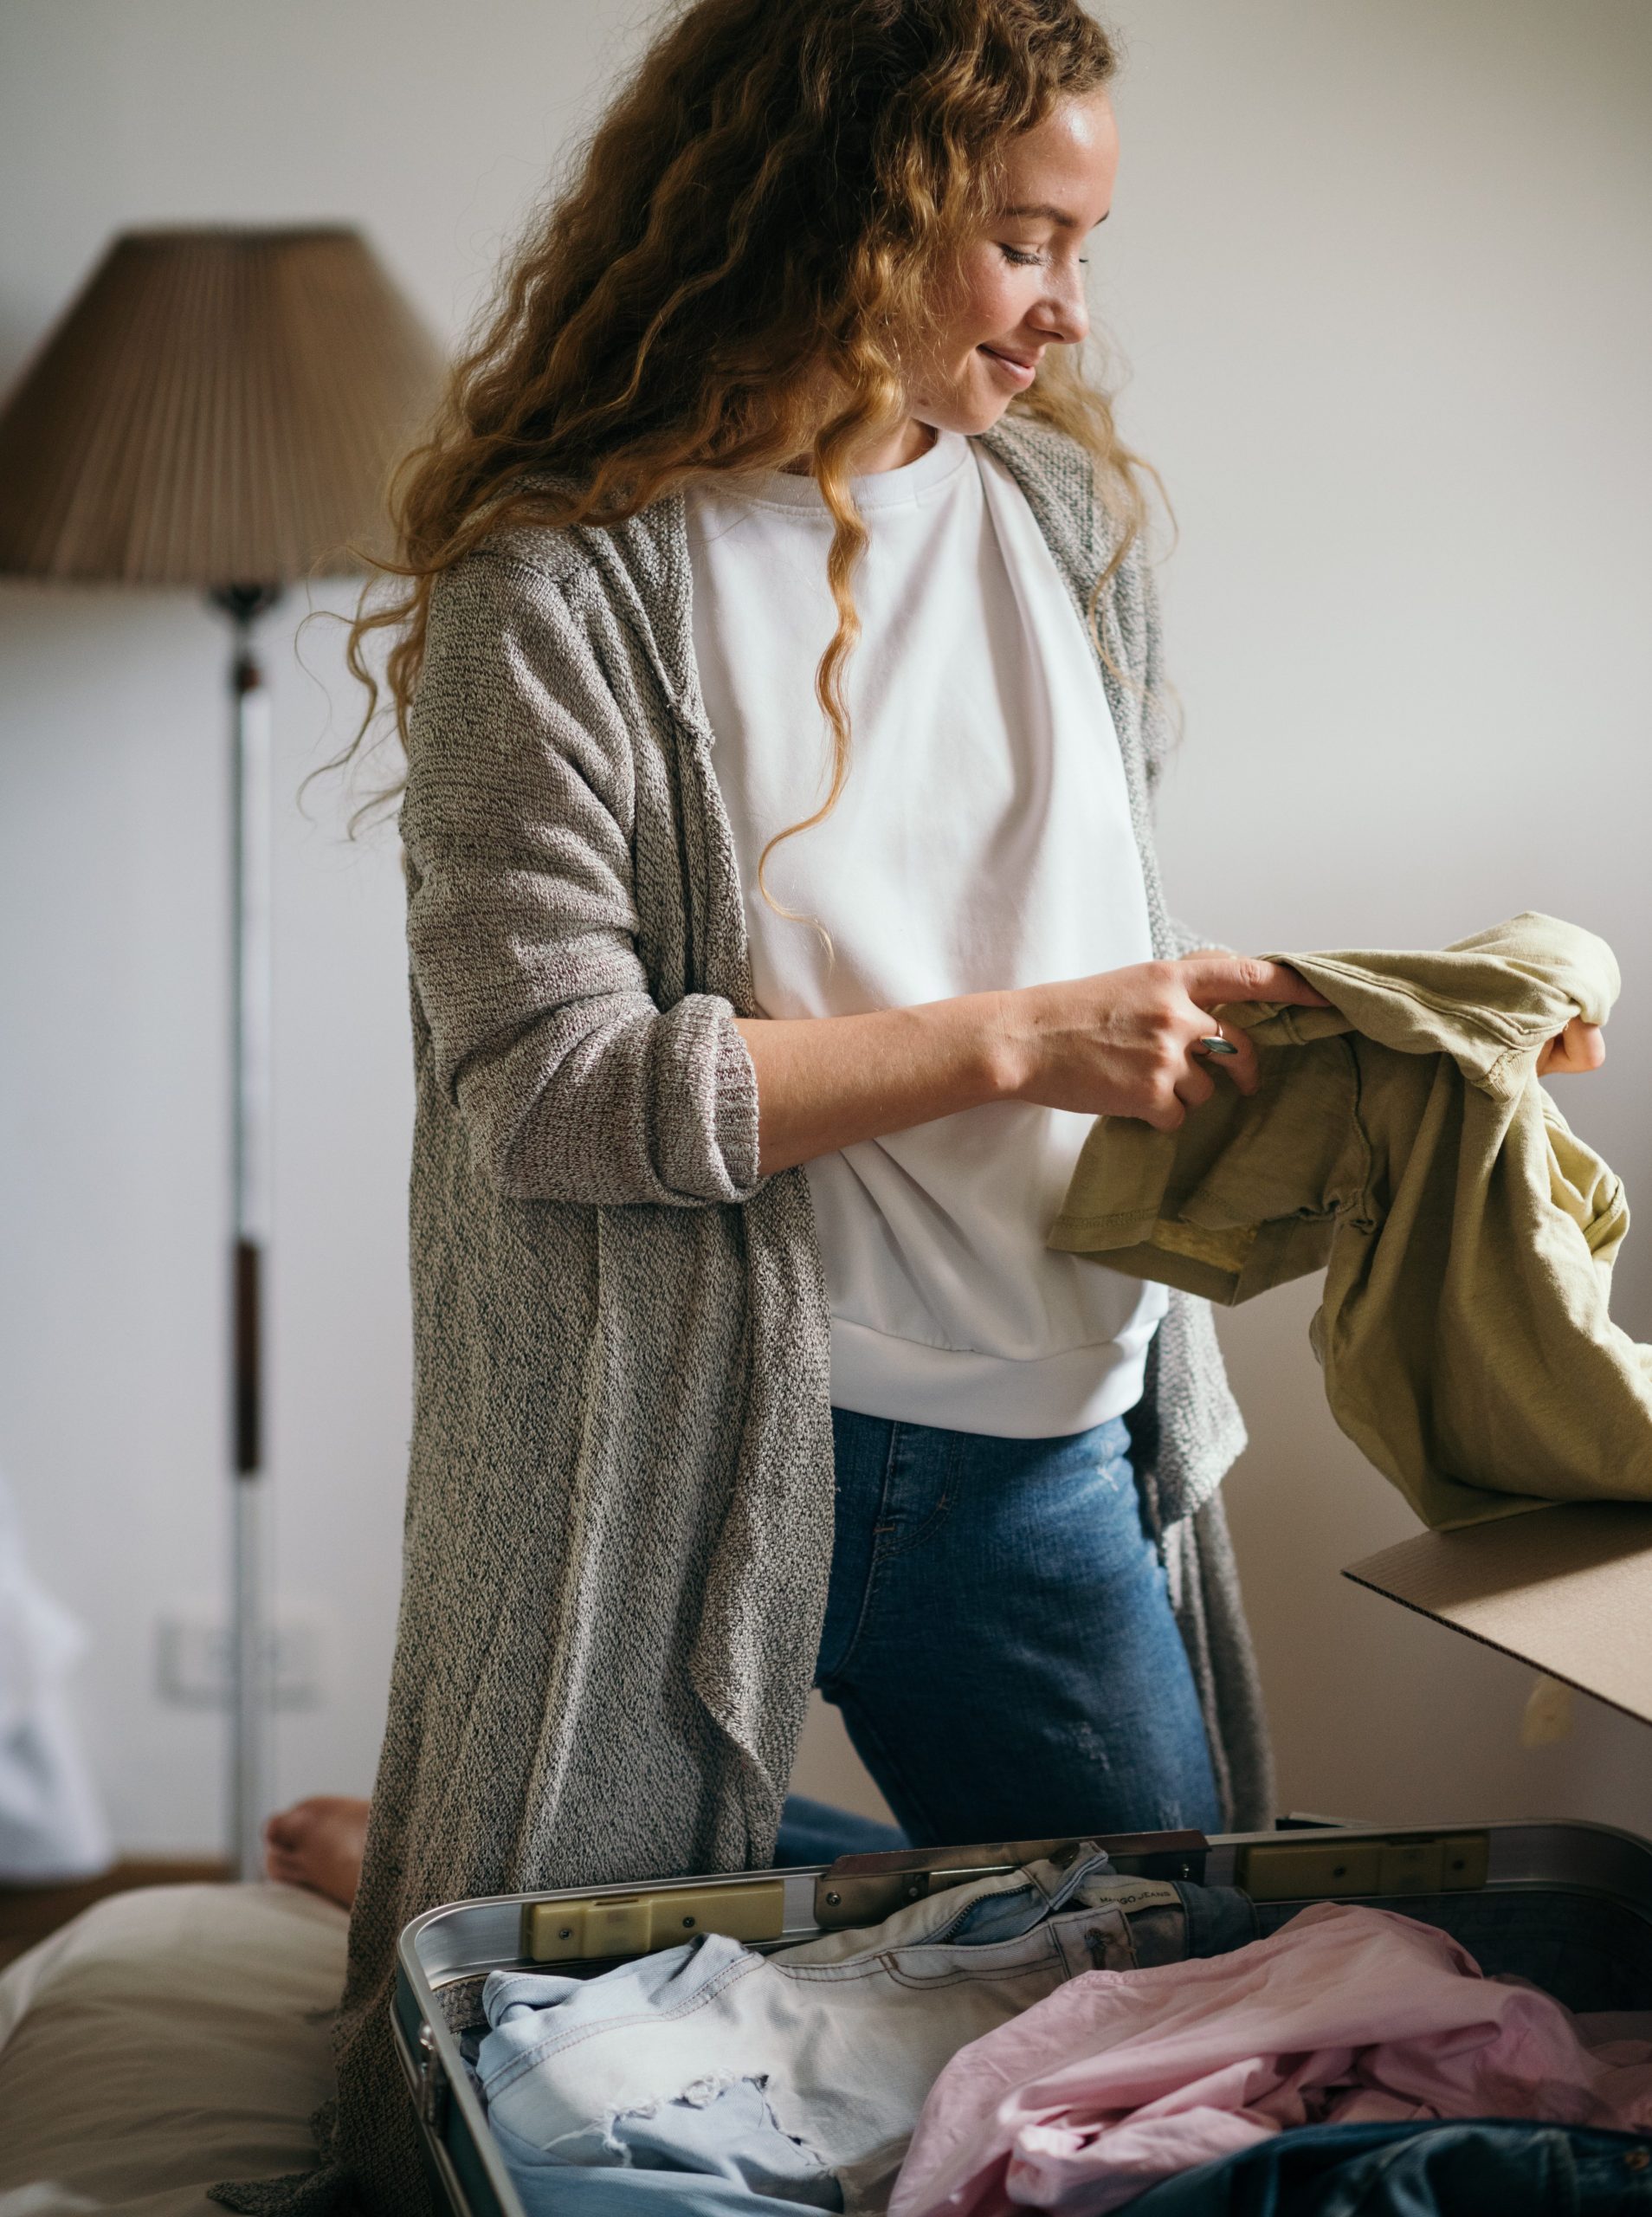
[0,229,442,587]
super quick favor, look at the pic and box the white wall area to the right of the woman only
[1102,0,1652,1825]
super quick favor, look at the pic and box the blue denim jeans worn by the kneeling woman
[816,1408,1220,1846]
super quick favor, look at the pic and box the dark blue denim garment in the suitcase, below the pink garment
[1126,2117,1652,2217]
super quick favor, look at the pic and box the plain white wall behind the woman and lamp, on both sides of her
[0,0,1652,1849]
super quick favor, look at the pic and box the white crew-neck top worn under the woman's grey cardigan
[687,432,1165,1438]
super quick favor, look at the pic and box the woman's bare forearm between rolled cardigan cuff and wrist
[736,993,1018,1177]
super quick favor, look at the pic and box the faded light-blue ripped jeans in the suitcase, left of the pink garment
[477,1853,1255,2217]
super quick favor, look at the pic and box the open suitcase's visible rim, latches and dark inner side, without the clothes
[395,1820,1652,2217]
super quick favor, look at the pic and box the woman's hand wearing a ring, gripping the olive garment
[1003,953,1326,1131]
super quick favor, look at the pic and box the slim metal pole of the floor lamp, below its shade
[213,585,280,1878]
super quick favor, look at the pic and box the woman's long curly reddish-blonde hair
[346,0,1145,882]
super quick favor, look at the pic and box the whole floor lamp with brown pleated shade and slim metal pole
[0,226,442,1878]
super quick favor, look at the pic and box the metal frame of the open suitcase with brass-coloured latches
[392,1822,1652,2217]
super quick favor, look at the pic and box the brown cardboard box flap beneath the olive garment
[1344,1501,1652,1723]
